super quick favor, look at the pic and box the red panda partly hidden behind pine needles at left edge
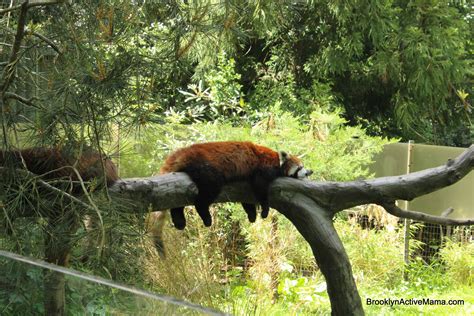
[0,147,119,193]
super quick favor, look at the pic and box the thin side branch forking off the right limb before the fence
[380,203,474,225]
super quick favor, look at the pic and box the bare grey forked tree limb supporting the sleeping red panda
[110,145,474,315]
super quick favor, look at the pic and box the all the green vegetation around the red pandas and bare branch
[0,0,474,315]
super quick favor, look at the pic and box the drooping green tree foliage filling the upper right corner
[255,0,472,145]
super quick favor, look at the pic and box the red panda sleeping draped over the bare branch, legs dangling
[160,141,313,230]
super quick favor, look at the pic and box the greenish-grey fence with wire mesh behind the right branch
[360,142,474,263]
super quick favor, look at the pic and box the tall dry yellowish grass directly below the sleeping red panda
[144,210,230,306]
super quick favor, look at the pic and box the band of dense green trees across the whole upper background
[0,0,473,146]
